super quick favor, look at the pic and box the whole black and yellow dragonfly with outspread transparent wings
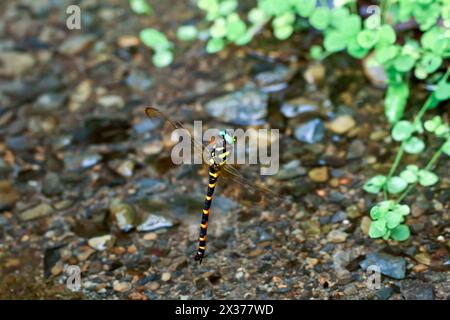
[145,107,287,264]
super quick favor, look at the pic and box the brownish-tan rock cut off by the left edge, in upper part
[0,51,35,77]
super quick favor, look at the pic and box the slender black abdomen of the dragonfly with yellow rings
[195,166,219,263]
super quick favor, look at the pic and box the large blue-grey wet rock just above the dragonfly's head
[205,87,269,125]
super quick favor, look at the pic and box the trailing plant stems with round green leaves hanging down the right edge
[363,69,450,241]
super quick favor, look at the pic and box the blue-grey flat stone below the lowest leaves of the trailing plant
[360,252,406,279]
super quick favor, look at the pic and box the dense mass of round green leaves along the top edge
[134,0,450,124]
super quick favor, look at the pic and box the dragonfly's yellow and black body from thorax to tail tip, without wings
[194,140,230,263]
